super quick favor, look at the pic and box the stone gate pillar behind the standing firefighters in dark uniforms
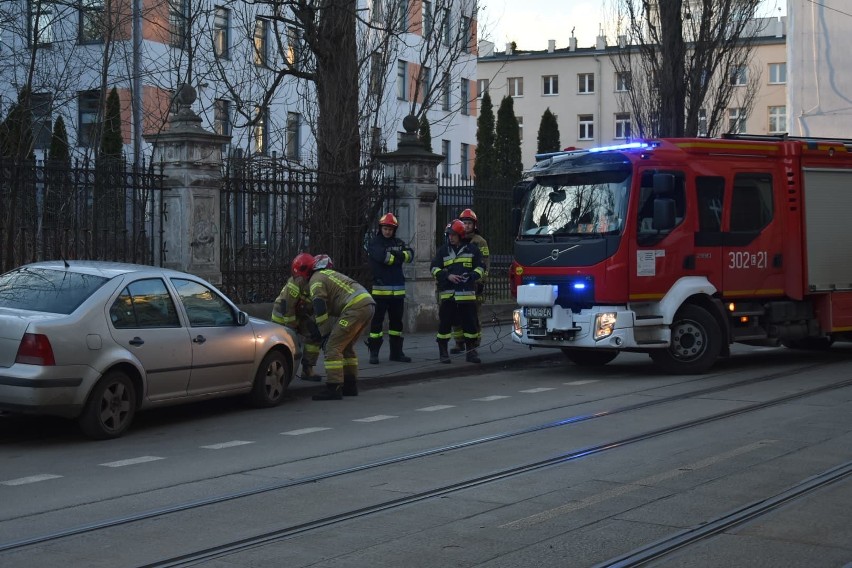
[378,115,444,333]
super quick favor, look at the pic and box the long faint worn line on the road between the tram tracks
[500,440,775,529]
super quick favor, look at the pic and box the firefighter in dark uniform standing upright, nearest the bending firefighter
[367,213,414,363]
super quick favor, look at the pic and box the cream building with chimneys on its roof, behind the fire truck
[477,18,787,166]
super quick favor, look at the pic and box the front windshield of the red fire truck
[520,170,631,237]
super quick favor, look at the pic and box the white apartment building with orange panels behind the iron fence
[0,0,477,174]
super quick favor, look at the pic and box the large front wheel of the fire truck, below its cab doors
[650,305,722,374]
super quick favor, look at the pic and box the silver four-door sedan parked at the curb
[0,261,301,439]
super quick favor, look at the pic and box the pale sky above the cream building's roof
[478,0,787,51]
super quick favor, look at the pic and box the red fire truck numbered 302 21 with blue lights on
[510,135,852,373]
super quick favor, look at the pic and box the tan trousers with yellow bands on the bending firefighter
[325,301,375,385]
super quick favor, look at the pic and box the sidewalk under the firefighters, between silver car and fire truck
[288,304,562,394]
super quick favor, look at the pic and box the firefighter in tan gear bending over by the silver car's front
[292,253,375,400]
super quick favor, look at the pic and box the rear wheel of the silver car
[78,371,136,440]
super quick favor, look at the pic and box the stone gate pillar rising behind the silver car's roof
[144,85,231,286]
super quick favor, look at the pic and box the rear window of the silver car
[0,268,108,314]
